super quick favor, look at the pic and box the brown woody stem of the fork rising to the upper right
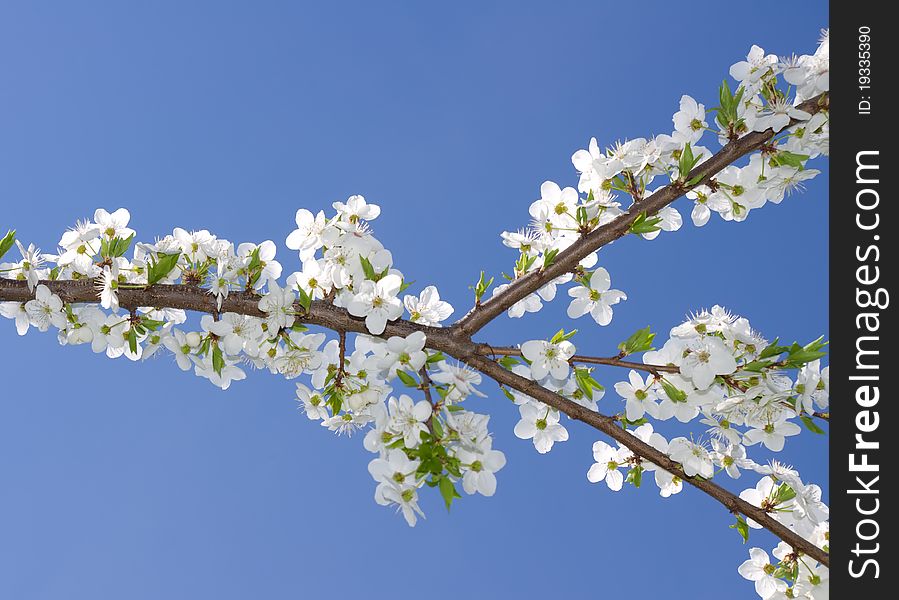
[453,92,830,337]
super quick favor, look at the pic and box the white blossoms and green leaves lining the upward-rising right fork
[494,31,829,338]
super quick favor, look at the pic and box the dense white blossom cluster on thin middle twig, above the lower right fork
[615,305,829,452]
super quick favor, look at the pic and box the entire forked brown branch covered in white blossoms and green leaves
[0,32,829,599]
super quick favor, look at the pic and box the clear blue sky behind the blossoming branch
[0,2,828,600]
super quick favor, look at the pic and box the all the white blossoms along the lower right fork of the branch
[501,305,829,598]
